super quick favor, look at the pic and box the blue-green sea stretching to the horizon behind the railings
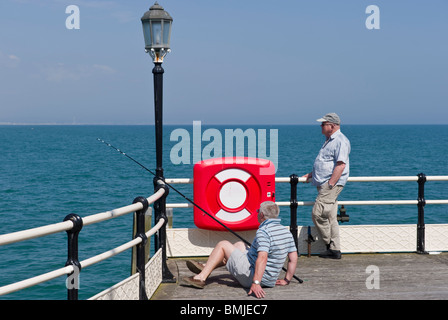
[0,124,448,300]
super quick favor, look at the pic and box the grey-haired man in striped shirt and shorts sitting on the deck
[183,201,298,298]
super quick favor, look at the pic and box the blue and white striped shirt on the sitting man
[247,219,297,287]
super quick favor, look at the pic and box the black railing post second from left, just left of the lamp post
[133,197,149,300]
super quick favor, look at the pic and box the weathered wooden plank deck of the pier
[152,252,448,300]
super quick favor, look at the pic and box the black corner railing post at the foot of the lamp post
[154,177,176,283]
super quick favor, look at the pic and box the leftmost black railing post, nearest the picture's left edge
[64,213,83,300]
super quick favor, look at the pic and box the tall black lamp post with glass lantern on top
[141,2,175,282]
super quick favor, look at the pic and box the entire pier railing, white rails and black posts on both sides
[0,173,448,300]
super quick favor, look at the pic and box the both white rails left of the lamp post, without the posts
[0,188,165,296]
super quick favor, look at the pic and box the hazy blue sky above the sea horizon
[0,0,448,125]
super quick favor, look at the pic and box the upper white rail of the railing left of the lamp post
[0,188,165,246]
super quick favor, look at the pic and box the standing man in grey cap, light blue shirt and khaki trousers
[303,113,350,259]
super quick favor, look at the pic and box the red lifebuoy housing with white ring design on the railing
[193,157,275,231]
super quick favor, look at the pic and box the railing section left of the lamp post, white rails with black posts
[0,182,168,300]
